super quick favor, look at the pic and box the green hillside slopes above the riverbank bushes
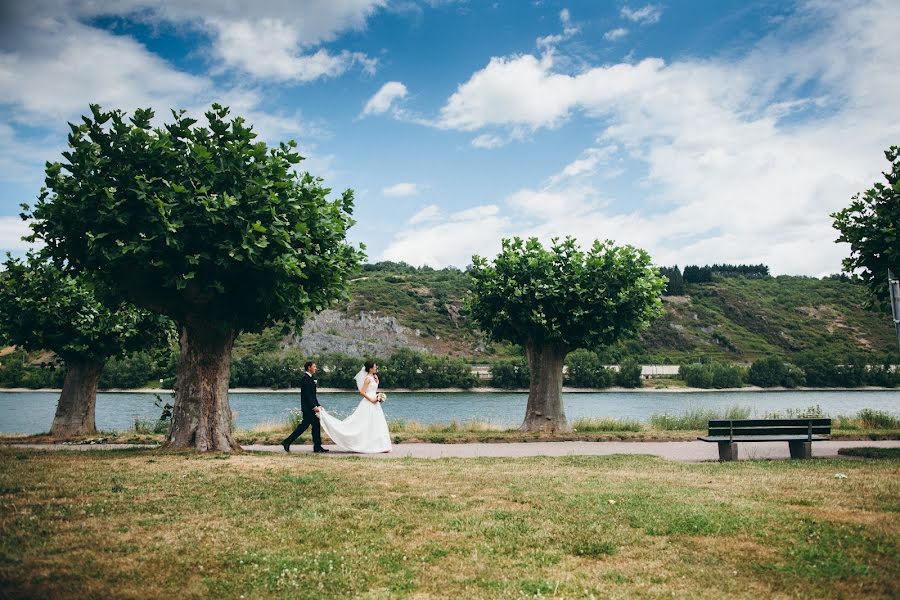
[276,263,900,363]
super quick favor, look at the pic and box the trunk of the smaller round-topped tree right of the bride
[522,344,569,432]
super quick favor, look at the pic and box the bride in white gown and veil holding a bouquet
[317,360,391,454]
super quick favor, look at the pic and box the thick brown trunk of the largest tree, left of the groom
[163,321,241,452]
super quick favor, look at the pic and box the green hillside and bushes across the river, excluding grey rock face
[0,263,900,389]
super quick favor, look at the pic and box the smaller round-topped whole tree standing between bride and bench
[468,237,665,431]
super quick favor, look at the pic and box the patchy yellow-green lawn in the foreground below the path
[0,448,900,599]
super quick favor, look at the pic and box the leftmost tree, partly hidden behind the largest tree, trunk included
[0,256,172,437]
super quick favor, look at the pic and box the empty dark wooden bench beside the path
[697,418,831,460]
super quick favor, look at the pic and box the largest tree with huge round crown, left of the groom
[25,104,362,451]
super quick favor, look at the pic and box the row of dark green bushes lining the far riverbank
[0,348,900,390]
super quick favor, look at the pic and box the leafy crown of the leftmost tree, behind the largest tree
[0,255,172,361]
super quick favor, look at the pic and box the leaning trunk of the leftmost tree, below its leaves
[50,360,104,438]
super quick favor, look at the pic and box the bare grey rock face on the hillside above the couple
[285,310,430,356]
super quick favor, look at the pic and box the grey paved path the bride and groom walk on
[7,440,900,461]
